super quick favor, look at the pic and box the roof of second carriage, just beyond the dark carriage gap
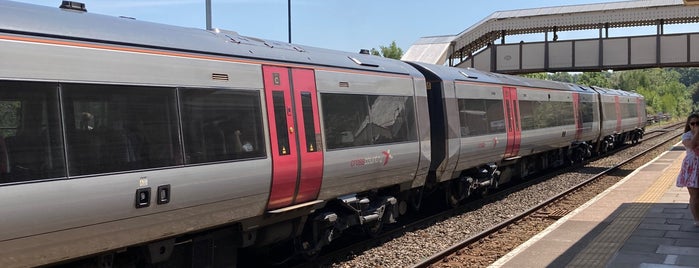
[410,62,594,93]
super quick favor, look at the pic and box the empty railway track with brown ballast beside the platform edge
[412,124,683,268]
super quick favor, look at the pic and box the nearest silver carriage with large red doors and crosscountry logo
[0,1,430,267]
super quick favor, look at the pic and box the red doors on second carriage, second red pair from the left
[502,87,522,158]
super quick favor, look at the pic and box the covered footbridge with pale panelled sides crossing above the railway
[402,0,699,74]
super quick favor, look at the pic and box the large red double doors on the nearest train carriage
[262,66,323,210]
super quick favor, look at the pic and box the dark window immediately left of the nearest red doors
[180,88,265,164]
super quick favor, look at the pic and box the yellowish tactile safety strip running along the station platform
[567,154,684,268]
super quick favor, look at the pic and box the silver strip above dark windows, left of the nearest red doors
[0,38,262,89]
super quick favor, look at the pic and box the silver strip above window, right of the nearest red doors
[316,70,415,96]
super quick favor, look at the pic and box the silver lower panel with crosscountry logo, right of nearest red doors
[318,142,420,199]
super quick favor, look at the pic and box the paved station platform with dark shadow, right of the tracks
[490,143,699,268]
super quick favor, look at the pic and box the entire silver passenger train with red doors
[0,1,646,267]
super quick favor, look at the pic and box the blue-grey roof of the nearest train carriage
[0,0,421,76]
